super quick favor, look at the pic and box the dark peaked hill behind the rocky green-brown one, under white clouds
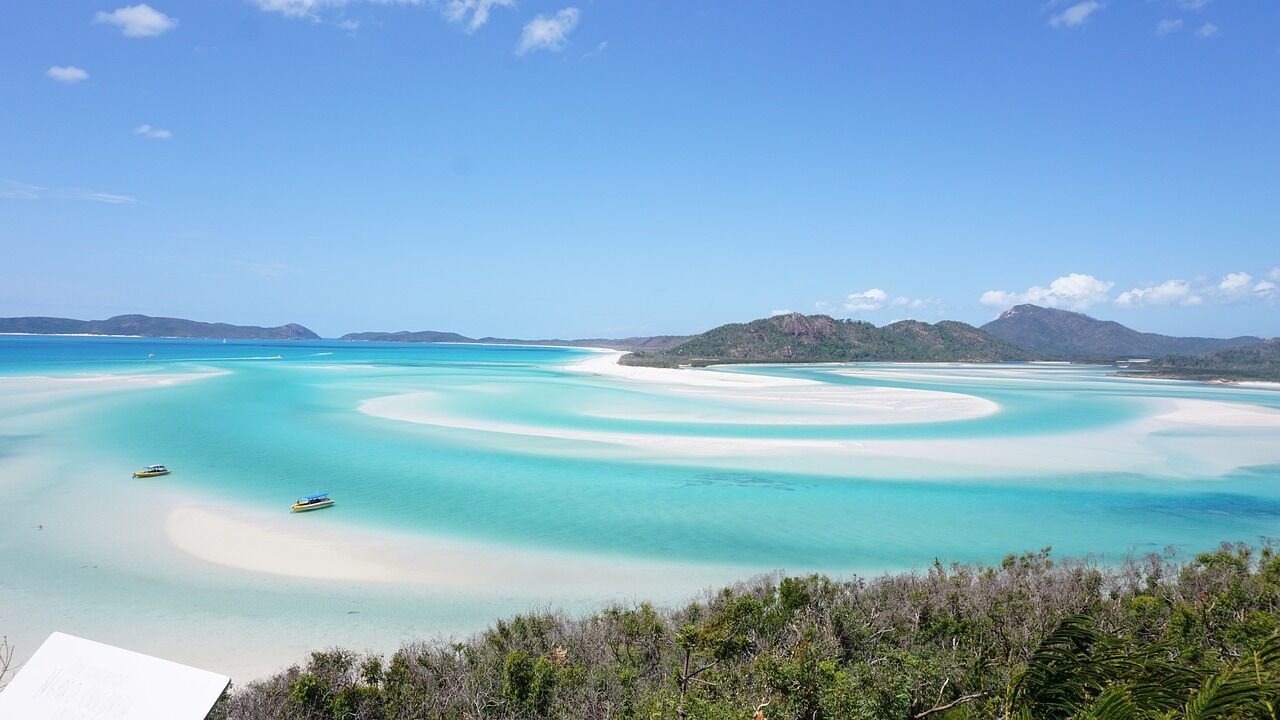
[982,305,1262,360]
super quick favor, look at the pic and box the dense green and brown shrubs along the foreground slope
[215,544,1280,720]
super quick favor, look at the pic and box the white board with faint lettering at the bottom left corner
[0,633,230,720]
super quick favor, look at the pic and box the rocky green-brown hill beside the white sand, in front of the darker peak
[622,313,1030,366]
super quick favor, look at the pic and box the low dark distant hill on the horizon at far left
[0,315,320,340]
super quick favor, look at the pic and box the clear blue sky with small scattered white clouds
[0,0,1280,338]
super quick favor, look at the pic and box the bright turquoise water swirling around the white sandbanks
[0,337,1280,571]
